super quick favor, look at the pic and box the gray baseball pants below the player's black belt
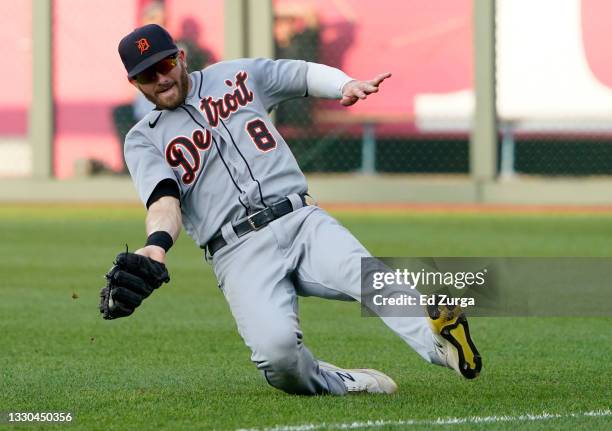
[212,201,437,395]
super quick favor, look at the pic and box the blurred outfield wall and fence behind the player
[0,0,612,204]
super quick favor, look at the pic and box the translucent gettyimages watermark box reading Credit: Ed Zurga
[361,257,612,317]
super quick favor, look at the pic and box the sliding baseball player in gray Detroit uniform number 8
[100,25,481,395]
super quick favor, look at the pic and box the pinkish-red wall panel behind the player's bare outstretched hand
[276,0,472,116]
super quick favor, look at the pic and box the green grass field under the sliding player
[0,207,612,431]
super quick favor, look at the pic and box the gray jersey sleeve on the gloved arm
[124,131,176,205]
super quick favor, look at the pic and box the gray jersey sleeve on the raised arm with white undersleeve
[249,58,308,111]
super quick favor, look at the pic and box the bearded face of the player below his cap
[130,50,190,109]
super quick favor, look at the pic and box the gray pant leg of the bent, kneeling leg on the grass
[213,228,346,395]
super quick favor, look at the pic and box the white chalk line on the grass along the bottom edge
[237,410,612,431]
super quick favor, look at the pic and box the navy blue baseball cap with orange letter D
[119,24,178,79]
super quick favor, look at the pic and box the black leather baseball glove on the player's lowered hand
[100,252,170,320]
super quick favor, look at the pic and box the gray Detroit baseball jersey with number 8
[124,59,314,245]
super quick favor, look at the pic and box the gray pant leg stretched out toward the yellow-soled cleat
[295,208,439,363]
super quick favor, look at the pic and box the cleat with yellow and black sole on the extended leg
[427,305,482,379]
